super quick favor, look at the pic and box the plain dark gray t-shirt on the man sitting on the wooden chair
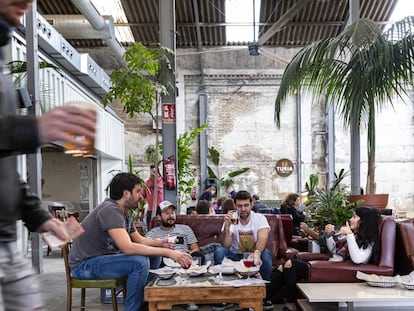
[69,199,136,268]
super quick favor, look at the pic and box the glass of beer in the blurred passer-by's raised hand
[64,101,98,157]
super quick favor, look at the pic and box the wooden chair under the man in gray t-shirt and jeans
[62,243,127,311]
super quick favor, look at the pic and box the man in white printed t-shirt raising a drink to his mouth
[213,190,273,311]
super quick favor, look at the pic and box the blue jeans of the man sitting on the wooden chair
[72,254,159,311]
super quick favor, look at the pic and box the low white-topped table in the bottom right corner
[298,283,414,311]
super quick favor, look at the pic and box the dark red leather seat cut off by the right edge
[395,218,414,275]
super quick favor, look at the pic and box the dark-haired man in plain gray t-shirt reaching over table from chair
[69,173,192,311]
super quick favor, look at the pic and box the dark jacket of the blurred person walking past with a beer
[0,21,51,242]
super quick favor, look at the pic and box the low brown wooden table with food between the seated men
[144,278,266,311]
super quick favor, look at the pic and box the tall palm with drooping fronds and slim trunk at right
[275,17,414,193]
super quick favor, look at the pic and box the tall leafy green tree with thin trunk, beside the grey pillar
[103,43,174,217]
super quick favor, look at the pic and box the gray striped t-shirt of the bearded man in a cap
[145,224,198,253]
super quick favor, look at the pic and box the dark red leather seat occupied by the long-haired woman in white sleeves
[299,216,396,283]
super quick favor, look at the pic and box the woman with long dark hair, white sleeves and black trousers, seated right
[269,206,380,311]
